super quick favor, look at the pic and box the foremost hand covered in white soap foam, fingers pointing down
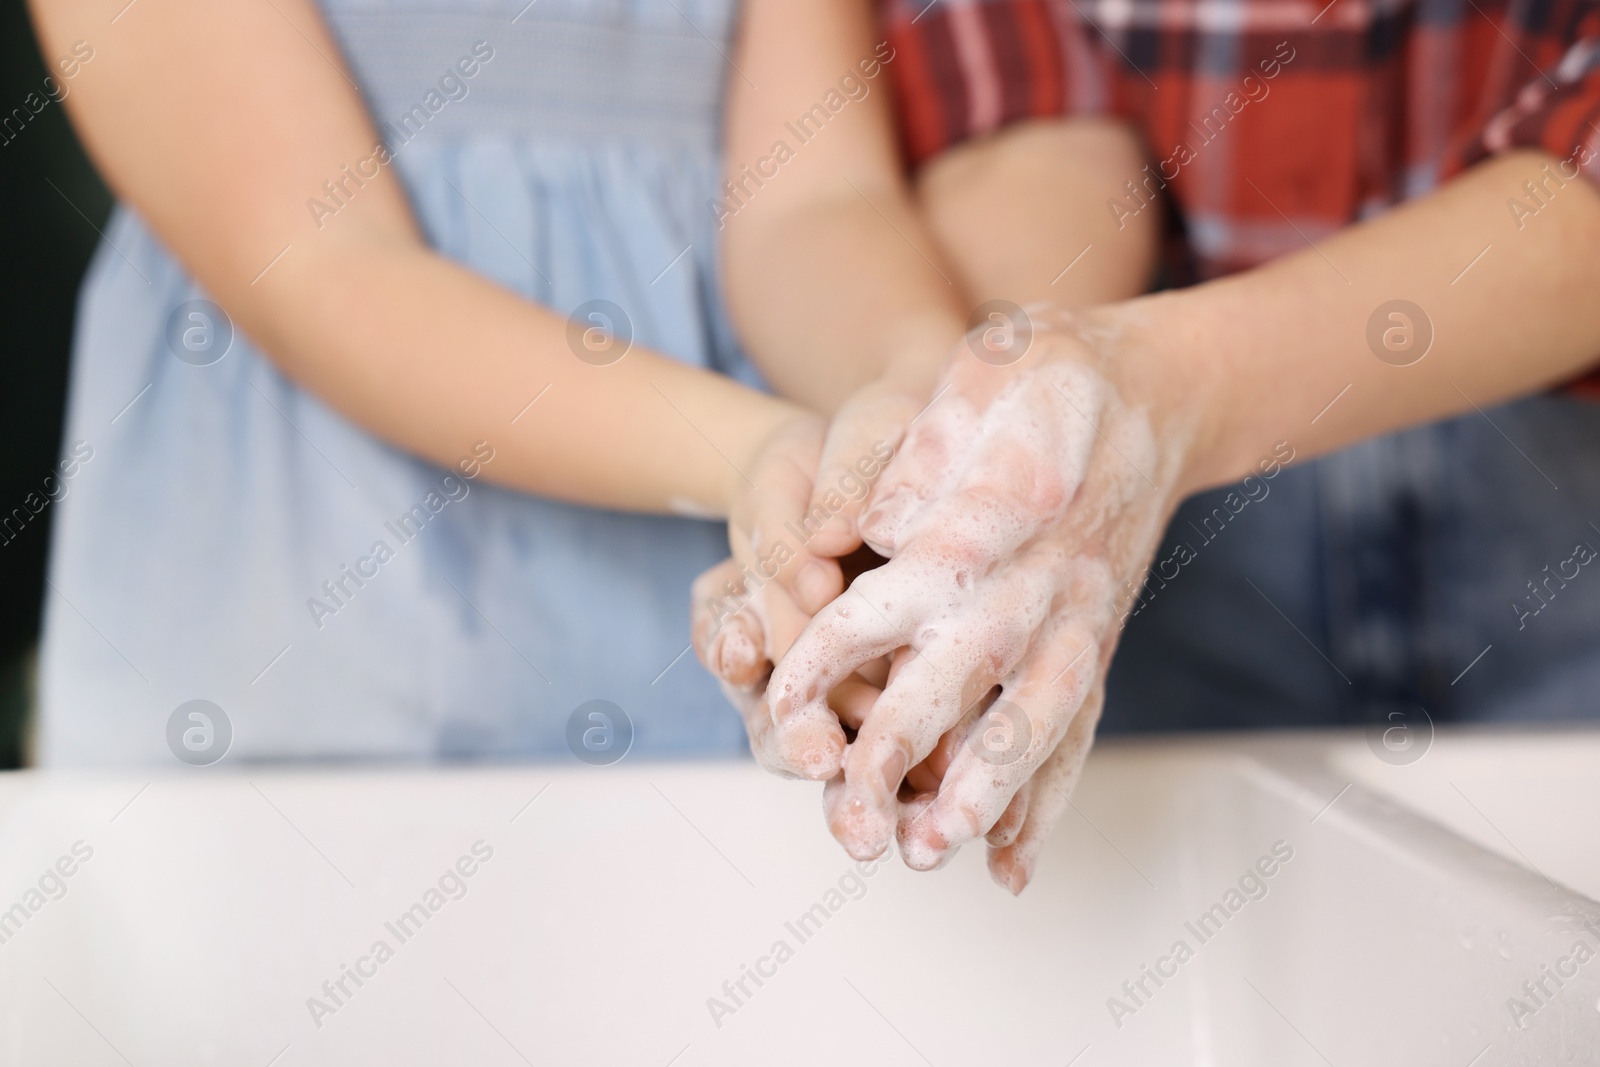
[766,310,1206,893]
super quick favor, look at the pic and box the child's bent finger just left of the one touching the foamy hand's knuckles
[728,421,845,616]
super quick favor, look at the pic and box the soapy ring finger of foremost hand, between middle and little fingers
[902,604,1101,869]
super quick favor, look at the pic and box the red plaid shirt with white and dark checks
[880,0,1600,282]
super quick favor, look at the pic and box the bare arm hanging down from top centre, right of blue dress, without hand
[723,0,970,411]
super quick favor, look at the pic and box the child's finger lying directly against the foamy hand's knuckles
[803,386,926,566]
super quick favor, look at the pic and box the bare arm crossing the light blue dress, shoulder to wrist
[34,0,802,514]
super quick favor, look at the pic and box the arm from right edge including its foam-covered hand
[765,152,1600,891]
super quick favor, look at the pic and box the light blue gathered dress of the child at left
[40,0,757,765]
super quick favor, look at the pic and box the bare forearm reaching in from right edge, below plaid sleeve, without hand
[1139,154,1600,490]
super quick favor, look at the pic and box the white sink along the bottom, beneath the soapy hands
[0,733,1600,1067]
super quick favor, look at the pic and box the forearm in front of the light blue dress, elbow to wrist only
[243,236,802,515]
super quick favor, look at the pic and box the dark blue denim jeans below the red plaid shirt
[1101,395,1600,733]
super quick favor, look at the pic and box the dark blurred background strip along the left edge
[0,0,110,769]
